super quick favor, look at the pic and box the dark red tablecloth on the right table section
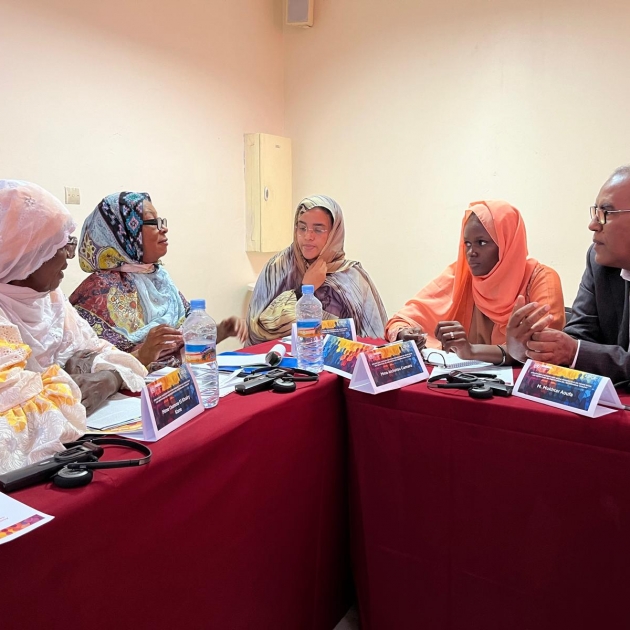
[346,376,630,630]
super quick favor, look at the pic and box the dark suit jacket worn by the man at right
[564,245,630,383]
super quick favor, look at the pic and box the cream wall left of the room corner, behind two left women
[0,0,284,346]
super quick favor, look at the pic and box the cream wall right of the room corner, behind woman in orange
[284,0,630,314]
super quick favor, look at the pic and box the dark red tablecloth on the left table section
[0,350,351,630]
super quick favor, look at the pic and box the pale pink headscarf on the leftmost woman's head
[0,179,75,284]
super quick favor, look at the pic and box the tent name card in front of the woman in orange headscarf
[350,341,429,394]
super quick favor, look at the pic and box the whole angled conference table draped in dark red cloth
[0,344,630,630]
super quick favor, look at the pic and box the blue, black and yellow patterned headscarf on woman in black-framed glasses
[79,192,151,273]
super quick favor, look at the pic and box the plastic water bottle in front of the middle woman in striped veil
[295,284,324,372]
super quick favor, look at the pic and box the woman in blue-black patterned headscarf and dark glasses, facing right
[70,192,245,370]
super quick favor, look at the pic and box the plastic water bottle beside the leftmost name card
[182,300,219,409]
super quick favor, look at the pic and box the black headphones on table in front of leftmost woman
[53,437,152,488]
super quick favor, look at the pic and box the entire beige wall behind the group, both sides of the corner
[0,0,630,334]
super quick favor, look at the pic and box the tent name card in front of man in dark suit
[513,359,623,418]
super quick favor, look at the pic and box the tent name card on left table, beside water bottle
[137,364,203,442]
